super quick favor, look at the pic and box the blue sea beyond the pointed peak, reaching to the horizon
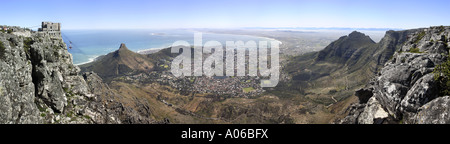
[62,30,272,64]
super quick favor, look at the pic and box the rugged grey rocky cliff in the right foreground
[339,26,450,124]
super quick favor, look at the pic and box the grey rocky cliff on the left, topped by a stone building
[0,27,154,124]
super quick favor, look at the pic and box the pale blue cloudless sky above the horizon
[0,0,450,30]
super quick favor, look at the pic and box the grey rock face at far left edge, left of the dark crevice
[0,31,43,124]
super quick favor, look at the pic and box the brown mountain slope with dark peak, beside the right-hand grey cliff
[268,30,417,121]
